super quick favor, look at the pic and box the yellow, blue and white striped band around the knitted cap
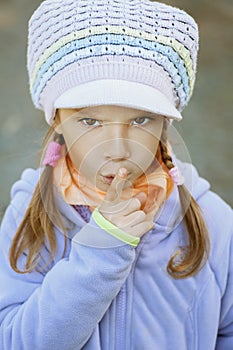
[31,26,195,105]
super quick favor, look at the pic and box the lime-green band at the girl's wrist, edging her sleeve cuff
[92,208,140,247]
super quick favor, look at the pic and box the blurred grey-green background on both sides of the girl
[0,0,233,220]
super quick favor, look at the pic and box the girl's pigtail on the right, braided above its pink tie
[159,120,209,278]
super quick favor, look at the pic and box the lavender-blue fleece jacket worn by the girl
[0,163,233,350]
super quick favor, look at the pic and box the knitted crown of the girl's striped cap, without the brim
[27,0,198,120]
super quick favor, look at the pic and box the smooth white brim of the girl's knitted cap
[54,79,182,120]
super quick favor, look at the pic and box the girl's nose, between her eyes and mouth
[104,123,130,160]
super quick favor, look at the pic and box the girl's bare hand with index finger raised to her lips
[99,168,154,237]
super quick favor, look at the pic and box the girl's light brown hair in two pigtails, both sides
[9,119,209,278]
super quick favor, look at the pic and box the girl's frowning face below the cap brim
[56,105,164,191]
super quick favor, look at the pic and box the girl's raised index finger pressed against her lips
[105,168,128,202]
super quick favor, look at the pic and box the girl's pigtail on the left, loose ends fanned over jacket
[9,127,66,273]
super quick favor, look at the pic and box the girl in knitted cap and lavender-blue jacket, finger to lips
[0,0,233,350]
